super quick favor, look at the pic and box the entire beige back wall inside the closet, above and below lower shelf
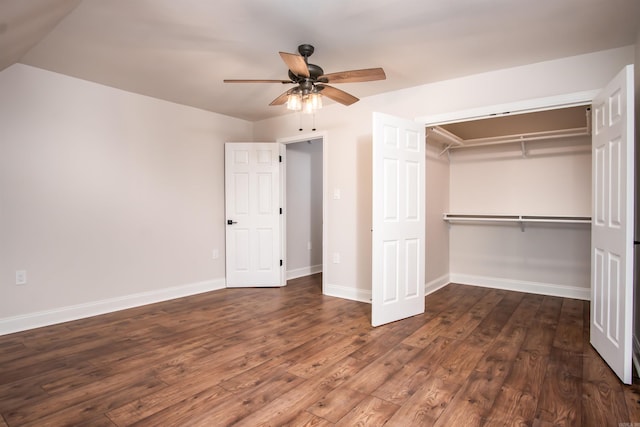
[442,123,591,299]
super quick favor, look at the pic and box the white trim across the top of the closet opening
[415,89,600,126]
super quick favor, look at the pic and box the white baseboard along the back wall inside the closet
[449,273,591,301]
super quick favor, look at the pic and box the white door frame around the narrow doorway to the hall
[276,131,329,294]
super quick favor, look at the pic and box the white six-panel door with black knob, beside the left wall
[225,142,282,287]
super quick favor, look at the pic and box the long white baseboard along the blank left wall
[0,278,226,335]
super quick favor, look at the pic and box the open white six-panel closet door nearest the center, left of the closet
[371,113,425,326]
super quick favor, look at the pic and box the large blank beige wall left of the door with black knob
[0,65,252,333]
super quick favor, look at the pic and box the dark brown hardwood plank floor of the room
[0,275,640,427]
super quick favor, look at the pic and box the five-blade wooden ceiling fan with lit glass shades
[224,44,386,112]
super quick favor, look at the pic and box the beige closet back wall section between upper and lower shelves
[450,136,591,216]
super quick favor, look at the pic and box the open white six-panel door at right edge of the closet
[590,65,634,384]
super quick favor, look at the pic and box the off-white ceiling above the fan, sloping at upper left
[0,0,640,121]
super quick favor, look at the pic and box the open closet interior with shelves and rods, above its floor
[427,106,592,299]
